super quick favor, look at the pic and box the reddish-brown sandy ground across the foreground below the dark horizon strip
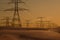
[0,30,60,40]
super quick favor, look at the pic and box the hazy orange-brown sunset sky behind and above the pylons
[0,0,60,25]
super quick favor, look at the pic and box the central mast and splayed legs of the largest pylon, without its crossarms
[12,0,22,27]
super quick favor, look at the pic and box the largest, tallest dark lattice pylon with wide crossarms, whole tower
[5,0,28,27]
